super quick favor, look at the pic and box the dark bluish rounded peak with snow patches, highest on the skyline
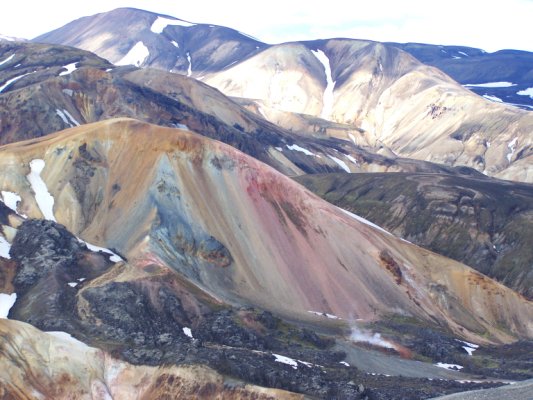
[33,8,267,76]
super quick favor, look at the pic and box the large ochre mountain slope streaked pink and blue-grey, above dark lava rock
[0,119,533,341]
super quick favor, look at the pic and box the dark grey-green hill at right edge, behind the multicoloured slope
[295,173,533,299]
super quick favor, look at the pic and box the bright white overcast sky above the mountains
[0,0,533,51]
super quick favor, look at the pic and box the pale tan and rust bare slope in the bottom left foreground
[0,320,303,400]
